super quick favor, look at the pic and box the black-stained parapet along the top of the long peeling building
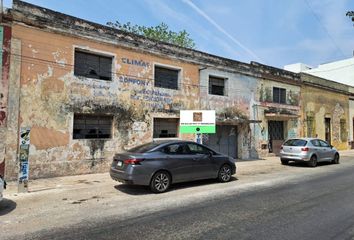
[7,0,300,85]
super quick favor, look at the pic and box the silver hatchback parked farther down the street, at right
[280,138,339,167]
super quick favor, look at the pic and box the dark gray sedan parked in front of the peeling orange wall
[110,141,236,193]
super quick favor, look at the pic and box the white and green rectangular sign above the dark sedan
[179,110,216,133]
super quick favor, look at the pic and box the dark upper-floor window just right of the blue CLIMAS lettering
[155,66,179,89]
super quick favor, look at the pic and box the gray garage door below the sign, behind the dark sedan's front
[203,125,237,158]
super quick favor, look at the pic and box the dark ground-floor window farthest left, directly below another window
[73,114,113,139]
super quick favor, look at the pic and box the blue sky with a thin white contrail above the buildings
[4,0,354,68]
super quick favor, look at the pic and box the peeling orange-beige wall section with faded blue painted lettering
[7,25,199,179]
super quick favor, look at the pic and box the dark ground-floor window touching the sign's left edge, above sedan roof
[153,118,178,138]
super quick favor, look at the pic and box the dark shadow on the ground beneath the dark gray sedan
[114,176,238,195]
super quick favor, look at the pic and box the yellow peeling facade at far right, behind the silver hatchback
[301,75,349,149]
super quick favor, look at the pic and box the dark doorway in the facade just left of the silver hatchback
[268,121,284,155]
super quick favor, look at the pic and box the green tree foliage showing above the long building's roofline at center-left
[107,21,195,49]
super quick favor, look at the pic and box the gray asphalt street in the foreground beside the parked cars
[12,156,354,240]
